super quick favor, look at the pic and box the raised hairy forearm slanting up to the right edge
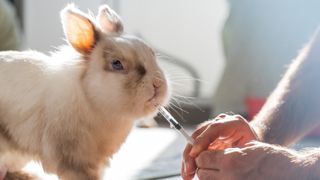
[251,28,320,145]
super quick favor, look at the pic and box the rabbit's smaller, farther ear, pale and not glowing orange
[97,5,123,34]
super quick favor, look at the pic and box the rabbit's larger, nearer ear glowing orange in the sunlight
[61,4,98,54]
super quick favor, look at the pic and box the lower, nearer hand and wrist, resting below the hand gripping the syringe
[196,141,315,180]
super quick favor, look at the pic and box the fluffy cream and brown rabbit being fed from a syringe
[0,4,170,180]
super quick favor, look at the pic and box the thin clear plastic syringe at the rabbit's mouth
[159,106,194,145]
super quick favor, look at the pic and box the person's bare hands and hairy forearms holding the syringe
[182,30,320,180]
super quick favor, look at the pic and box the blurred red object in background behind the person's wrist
[245,96,320,136]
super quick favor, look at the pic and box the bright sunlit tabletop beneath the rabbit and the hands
[21,128,320,180]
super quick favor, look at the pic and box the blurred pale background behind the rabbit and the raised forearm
[0,0,320,179]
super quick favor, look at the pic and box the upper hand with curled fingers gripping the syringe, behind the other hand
[181,114,257,180]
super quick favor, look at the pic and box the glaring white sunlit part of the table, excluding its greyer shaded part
[21,128,182,180]
